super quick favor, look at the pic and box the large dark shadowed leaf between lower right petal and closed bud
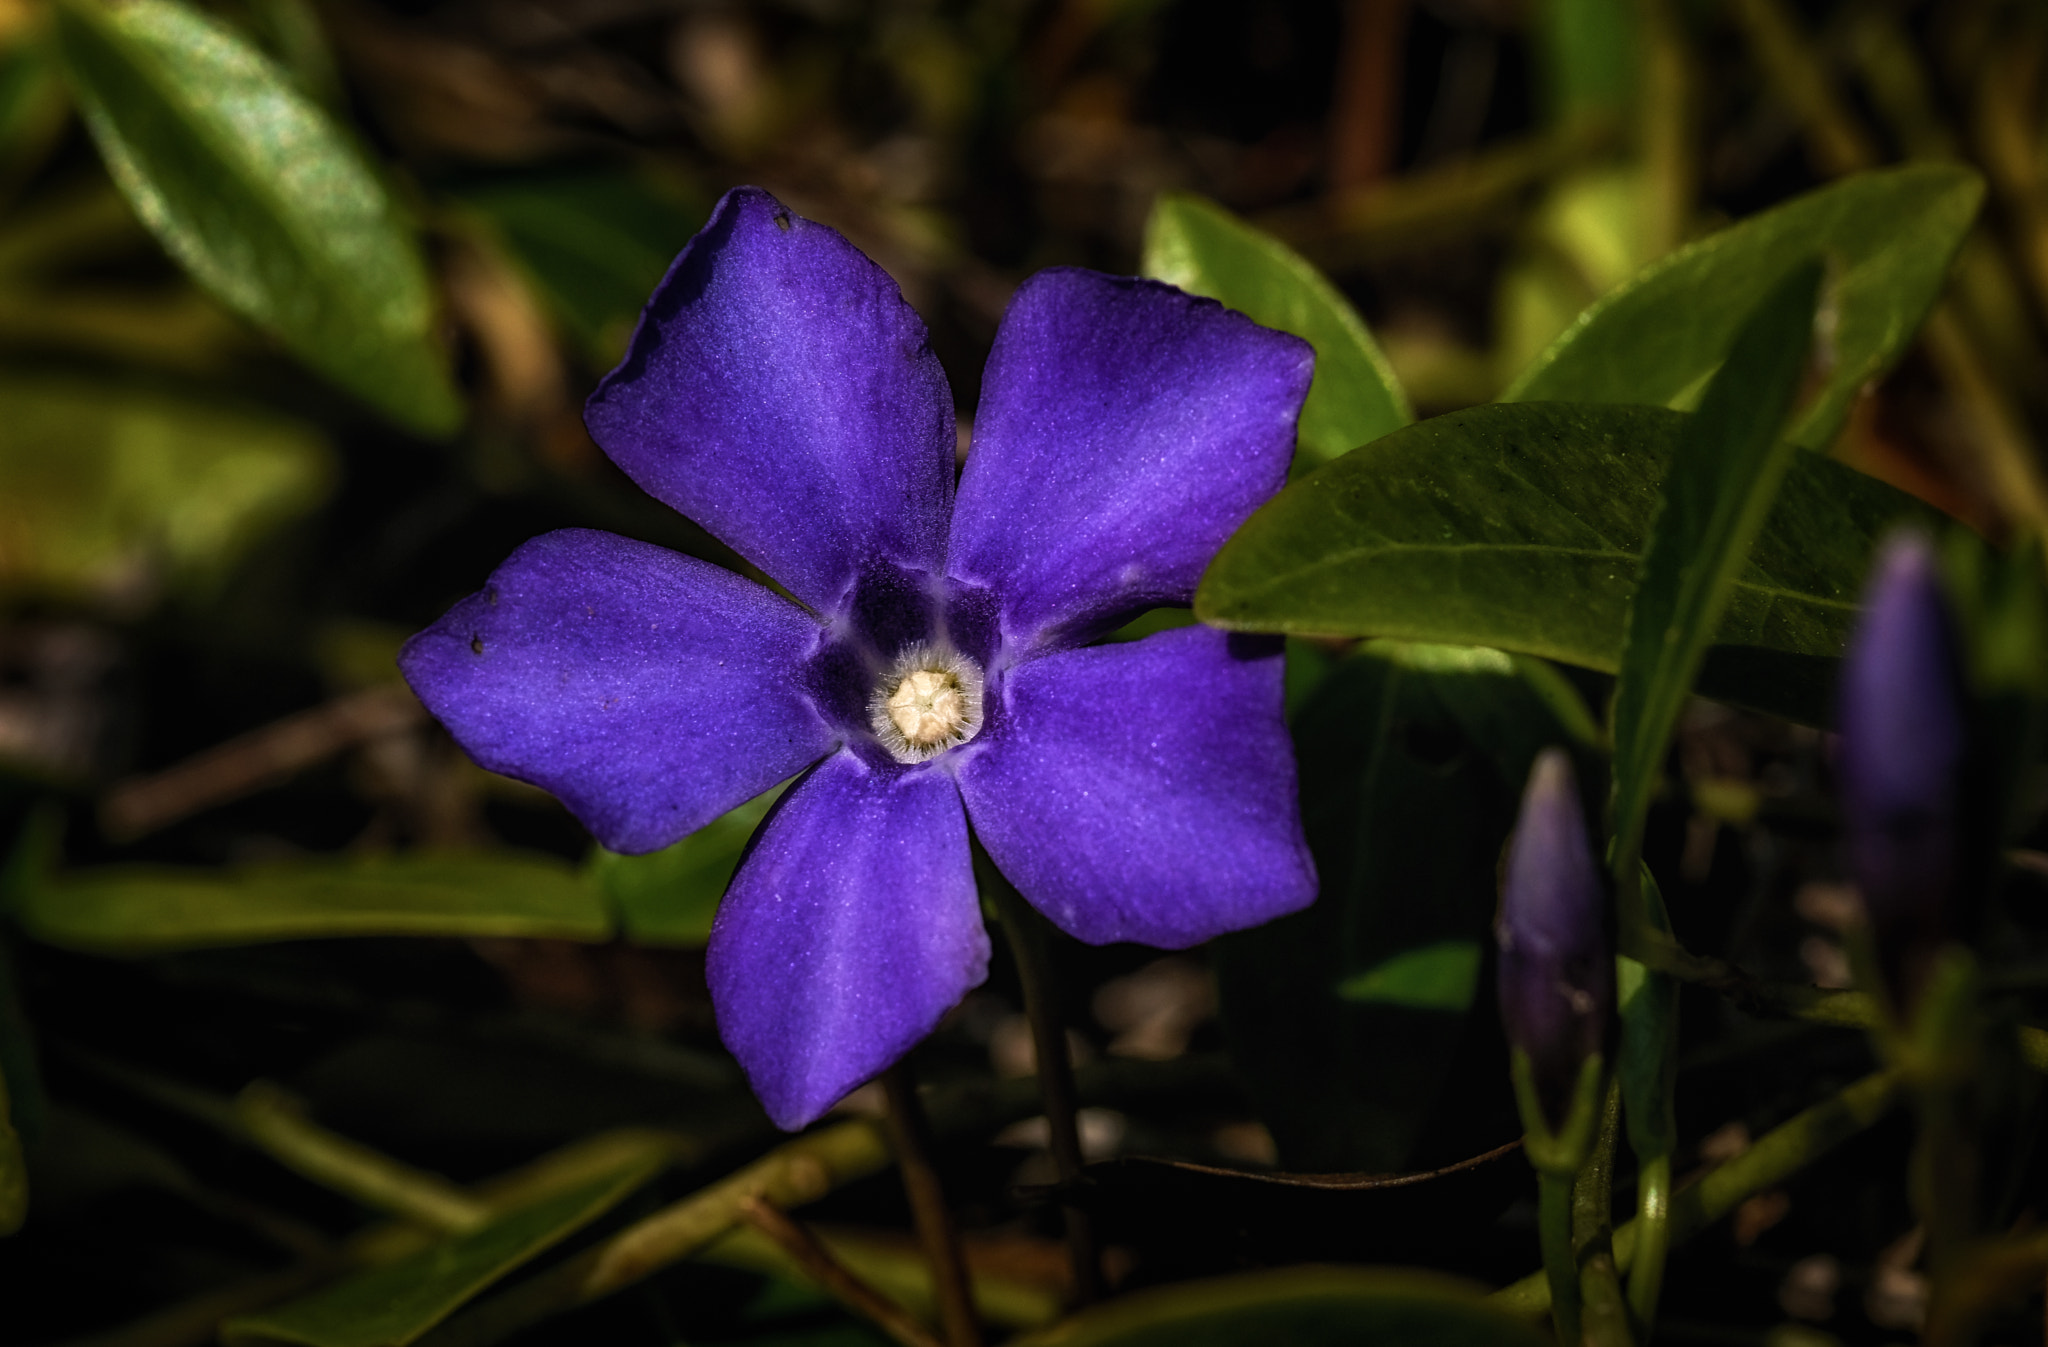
[1212,641,1583,1173]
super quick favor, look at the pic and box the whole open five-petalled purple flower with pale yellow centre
[399,188,1315,1128]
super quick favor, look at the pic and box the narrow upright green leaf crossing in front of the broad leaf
[1610,262,1821,859]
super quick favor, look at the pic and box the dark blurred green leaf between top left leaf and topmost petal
[457,168,711,364]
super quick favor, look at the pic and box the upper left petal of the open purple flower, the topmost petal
[584,186,954,612]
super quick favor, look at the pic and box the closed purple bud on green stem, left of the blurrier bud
[1493,749,1614,1130]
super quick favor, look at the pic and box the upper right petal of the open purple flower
[946,268,1315,651]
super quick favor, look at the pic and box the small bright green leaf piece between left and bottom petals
[584,786,782,948]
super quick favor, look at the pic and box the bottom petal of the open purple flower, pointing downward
[705,753,989,1130]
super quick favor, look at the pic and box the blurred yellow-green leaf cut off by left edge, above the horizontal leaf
[0,379,334,600]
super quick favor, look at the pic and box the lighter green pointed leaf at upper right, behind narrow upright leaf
[1501,164,1985,448]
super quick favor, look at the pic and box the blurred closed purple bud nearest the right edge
[1837,532,1968,1007]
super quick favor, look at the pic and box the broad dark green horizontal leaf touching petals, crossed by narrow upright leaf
[1194,403,1935,725]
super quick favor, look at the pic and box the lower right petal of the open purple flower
[958,626,1315,950]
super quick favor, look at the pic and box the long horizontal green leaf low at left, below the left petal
[14,854,610,954]
